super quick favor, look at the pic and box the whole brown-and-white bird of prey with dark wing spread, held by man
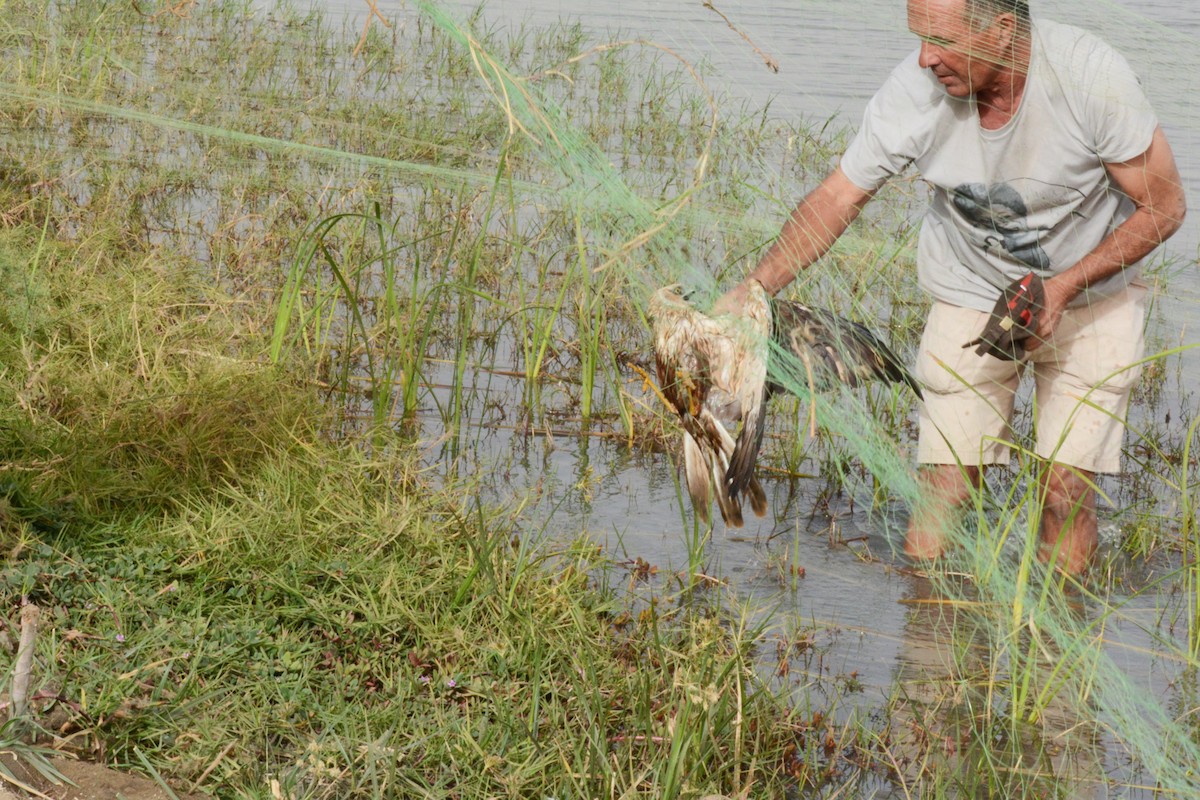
[647,279,922,528]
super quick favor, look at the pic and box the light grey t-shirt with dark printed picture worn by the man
[841,20,1158,311]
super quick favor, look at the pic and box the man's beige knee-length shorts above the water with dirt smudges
[916,284,1146,473]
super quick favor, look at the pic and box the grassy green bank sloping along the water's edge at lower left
[0,211,825,798]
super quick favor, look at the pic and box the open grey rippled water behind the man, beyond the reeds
[345,0,1200,235]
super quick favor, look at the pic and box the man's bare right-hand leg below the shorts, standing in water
[1038,464,1098,575]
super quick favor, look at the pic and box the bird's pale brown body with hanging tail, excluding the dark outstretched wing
[649,284,770,528]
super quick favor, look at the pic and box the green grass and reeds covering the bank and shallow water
[0,0,1200,799]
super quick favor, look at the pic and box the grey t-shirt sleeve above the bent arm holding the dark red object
[1080,38,1158,164]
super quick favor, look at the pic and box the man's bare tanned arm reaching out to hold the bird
[714,167,875,312]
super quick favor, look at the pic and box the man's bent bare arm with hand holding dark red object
[1028,128,1187,350]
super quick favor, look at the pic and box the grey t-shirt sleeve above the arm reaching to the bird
[840,54,929,191]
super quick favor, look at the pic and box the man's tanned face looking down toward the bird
[908,0,1007,97]
